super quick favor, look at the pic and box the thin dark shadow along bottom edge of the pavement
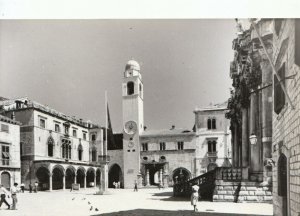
[92,209,270,216]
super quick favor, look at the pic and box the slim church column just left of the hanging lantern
[242,108,249,180]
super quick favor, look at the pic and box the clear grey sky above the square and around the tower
[0,19,236,132]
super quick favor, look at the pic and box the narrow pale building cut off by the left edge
[0,115,21,188]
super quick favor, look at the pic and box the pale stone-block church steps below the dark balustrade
[213,180,272,203]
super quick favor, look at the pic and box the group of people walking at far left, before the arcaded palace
[0,182,39,210]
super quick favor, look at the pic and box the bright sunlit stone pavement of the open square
[0,188,273,216]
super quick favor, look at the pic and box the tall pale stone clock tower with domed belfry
[122,60,144,188]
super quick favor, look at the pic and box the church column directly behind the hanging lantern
[250,92,261,181]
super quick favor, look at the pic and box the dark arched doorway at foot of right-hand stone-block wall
[277,154,288,216]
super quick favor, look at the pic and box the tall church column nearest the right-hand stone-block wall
[260,58,273,181]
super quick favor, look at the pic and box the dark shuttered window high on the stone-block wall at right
[274,63,285,114]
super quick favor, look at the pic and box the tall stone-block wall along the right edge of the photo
[270,19,300,216]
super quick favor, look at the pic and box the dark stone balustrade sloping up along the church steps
[173,167,248,200]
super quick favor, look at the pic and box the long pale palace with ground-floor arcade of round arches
[2,98,103,191]
